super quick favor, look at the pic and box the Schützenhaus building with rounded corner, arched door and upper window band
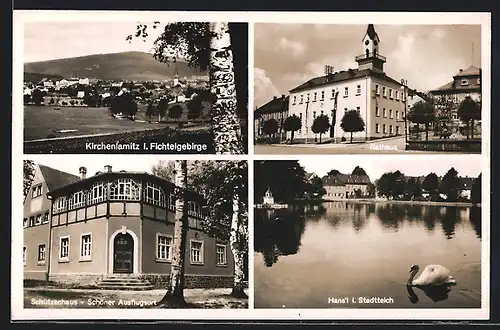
[23,165,234,287]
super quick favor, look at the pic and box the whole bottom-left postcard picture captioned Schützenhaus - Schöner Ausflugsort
[21,155,248,309]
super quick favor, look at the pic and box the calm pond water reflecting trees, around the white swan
[254,202,481,308]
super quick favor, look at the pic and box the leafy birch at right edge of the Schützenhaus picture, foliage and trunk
[191,161,248,298]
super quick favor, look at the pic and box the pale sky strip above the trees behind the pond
[299,155,481,182]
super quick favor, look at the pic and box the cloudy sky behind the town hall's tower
[254,23,481,107]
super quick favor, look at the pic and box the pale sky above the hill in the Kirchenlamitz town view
[24,22,164,63]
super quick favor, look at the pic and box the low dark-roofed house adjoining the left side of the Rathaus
[254,95,290,141]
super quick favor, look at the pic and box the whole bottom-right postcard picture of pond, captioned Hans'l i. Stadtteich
[254,155,487,309]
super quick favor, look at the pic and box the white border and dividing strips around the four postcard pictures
[11,10,491,320]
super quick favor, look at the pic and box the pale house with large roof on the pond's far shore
[321,171,371,200]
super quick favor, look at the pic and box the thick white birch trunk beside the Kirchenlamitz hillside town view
[209,22,243,154]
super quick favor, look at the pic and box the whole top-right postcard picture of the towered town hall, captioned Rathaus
[253,22,484,154]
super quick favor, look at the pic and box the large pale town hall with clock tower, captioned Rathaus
[288,24,407,142]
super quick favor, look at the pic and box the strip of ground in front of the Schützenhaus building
[24,287,248,308]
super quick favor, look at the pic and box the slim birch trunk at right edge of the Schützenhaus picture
[229,191,247,298]
